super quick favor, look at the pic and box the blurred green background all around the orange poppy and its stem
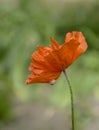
[0,0,99,130]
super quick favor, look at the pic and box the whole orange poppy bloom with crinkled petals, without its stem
[26,31,87,84]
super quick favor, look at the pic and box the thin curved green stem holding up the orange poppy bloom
[63,70,75,130]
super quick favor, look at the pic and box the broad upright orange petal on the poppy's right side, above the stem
[59,31,87,69]
